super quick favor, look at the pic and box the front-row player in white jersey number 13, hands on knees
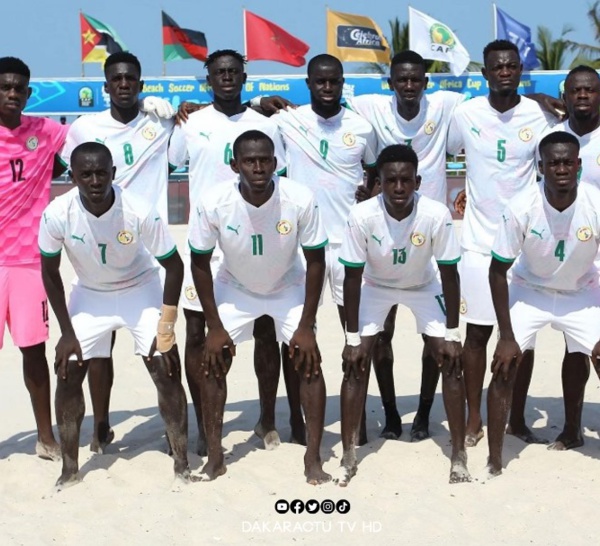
[338,144,471,485]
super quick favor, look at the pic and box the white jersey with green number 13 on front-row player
[339,193,460,289]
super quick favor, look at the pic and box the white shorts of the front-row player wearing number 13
[358,279,446,337]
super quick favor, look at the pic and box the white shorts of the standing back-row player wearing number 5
[458,248,497,326]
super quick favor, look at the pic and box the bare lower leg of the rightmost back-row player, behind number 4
[548,351,590,451]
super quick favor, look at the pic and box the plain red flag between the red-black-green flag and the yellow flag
[244,10,309,66]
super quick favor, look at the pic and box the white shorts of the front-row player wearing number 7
[69,272,163,360]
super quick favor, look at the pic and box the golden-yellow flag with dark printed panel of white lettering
[327,10,390,64]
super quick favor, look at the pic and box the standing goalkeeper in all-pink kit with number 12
[0,57,67,460]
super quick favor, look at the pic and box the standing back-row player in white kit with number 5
[448,40,554,447]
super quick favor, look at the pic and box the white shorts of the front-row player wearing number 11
[214,280,304,345]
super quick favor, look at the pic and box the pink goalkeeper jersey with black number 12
[0,116,69,266]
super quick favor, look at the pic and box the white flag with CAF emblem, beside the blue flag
[408,7,471,76]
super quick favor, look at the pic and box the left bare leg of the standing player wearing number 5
[462,323,492,447]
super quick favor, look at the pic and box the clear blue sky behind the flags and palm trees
[0,0,593,77]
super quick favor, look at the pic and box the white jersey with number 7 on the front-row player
[38,186,177,292]
